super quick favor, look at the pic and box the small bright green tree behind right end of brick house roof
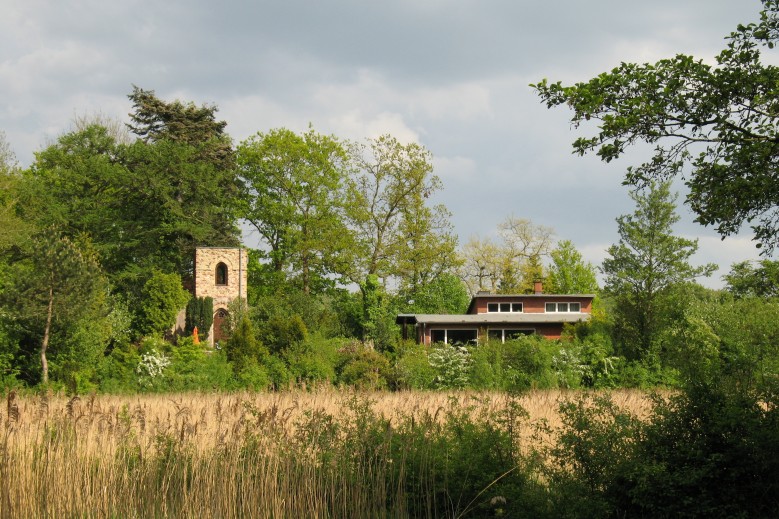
[546,240,598,294]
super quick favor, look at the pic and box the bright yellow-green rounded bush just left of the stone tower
[137,270,190,336]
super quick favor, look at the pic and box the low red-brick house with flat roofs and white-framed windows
[395,282,595,345]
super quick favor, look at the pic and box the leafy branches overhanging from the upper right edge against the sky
[531,0,779,253]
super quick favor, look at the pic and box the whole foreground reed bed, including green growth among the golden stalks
[0,389,650,517]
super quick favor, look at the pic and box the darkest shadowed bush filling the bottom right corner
[624,380,779,517]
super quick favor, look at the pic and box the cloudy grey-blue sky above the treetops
[0,0,779,288]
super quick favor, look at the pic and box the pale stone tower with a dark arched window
[195,247,249,344]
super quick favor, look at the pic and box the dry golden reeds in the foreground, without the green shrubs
[0,389,650,517]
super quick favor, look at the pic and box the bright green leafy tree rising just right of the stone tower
[238,128,351,293]
